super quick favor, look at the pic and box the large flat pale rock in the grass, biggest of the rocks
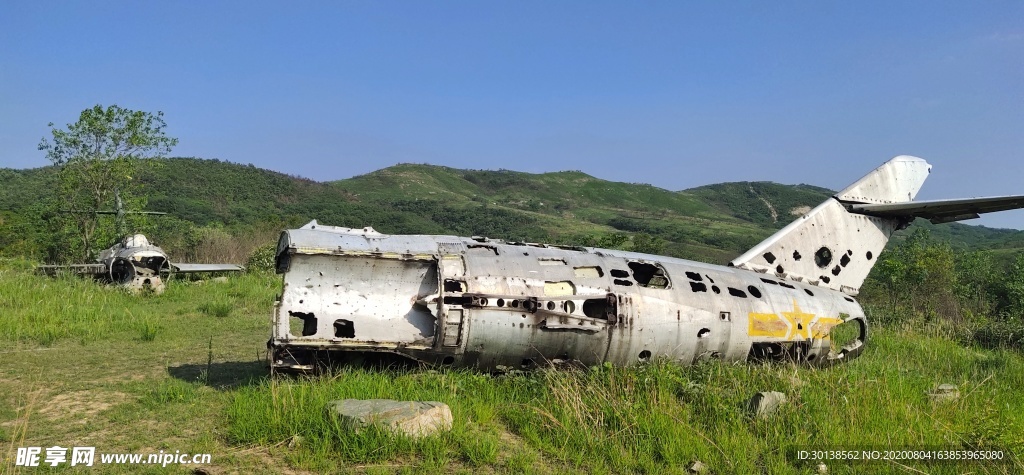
[327,399,452,437]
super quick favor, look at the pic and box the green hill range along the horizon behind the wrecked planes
[0,159,1024,263]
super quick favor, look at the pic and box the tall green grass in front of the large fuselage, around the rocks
[227,330,1024,473]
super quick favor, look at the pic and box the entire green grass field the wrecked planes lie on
[0,262,1024,474]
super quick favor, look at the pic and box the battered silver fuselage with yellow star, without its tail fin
[270,221,867,371]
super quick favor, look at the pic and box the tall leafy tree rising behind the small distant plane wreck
[39,104,178,258]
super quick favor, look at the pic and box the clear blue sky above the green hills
[6,0,1024,228]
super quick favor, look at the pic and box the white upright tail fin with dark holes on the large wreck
[729,156,932,295]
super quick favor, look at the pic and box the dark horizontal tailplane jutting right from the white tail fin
[846,196,1024,224]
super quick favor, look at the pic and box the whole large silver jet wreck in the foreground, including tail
[268,156,1024,371]
